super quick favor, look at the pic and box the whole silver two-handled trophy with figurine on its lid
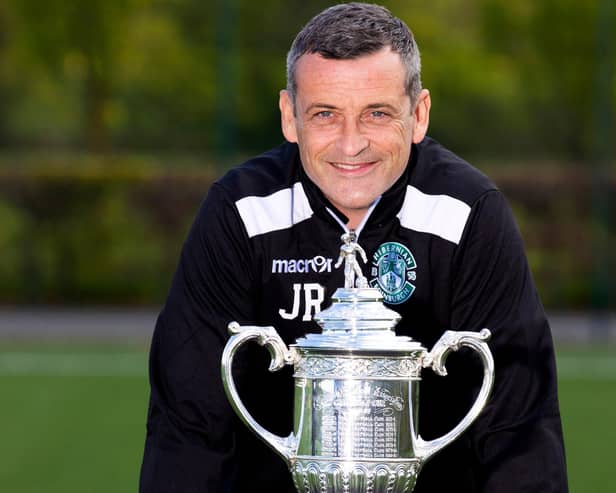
[222,234,494,493]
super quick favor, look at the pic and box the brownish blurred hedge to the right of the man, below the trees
[490,163,616,309]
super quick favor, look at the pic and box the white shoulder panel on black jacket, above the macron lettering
[235,182,313,238]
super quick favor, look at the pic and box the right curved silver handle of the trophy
[412,329,494,461]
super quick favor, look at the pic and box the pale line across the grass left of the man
[0,352,148,377]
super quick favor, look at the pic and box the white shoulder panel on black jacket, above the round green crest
[398,185,471,245]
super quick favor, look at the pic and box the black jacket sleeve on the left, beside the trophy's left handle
[139,185,254,493]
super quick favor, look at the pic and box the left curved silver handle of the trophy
[221,322,297,464]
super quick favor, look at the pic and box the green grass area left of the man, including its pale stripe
[0,348,148,493]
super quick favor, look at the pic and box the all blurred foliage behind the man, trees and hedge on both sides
[0,0,616,307]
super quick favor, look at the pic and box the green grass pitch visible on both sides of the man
[0,345,616,493]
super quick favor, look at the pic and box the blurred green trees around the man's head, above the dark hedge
[0,0,616,158]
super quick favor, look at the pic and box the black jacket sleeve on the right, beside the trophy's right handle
[451,190,568,493]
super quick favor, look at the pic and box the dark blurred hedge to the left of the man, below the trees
[0,160,217,304]
